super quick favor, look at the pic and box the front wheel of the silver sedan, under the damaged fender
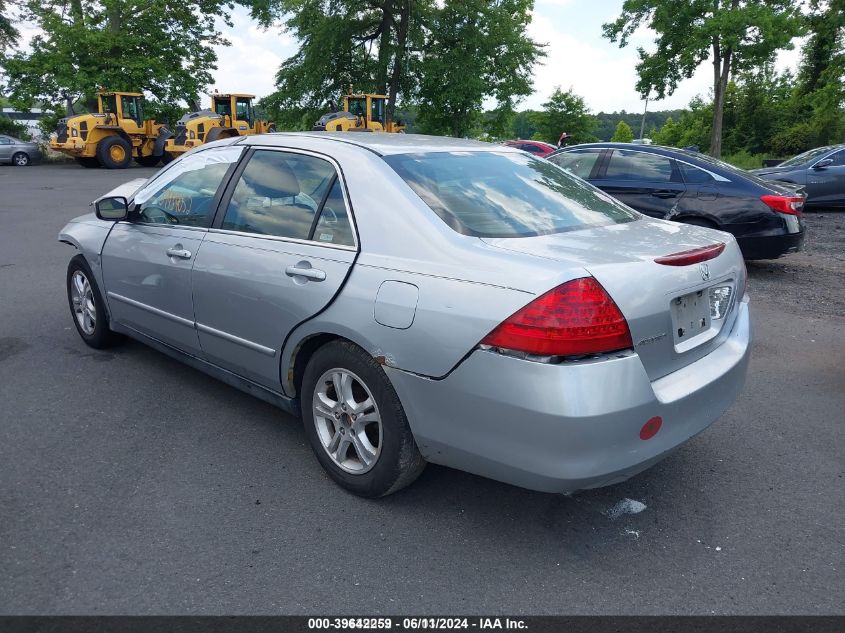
[67,255,124,349]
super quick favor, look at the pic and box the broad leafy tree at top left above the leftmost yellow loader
[2,0,231,115]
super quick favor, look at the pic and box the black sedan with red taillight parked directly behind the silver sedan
[547,143,805,259]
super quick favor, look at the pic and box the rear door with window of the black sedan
[591,149,686,219]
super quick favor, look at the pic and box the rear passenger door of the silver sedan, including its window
[193,148,357,389]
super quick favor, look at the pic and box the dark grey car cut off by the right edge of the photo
[752,145,845,209]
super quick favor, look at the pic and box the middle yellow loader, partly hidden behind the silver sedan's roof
[165,92,276,158]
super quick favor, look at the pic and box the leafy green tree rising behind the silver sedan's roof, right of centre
[418,0,544,136]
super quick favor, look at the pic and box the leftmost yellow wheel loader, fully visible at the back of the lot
[50,90,171,169]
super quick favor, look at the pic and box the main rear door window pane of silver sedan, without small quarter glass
[222,150,342,240]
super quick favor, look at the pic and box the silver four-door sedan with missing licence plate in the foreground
[59,133,750,496]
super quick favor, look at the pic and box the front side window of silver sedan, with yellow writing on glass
[133,147,241,226]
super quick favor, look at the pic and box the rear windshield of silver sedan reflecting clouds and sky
[384,152,639,237]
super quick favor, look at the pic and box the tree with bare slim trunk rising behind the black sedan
[603,0,803,156]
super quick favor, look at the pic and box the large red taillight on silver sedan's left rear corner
[481,277,634,356]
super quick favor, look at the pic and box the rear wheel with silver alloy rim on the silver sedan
[301,341,426,498]
